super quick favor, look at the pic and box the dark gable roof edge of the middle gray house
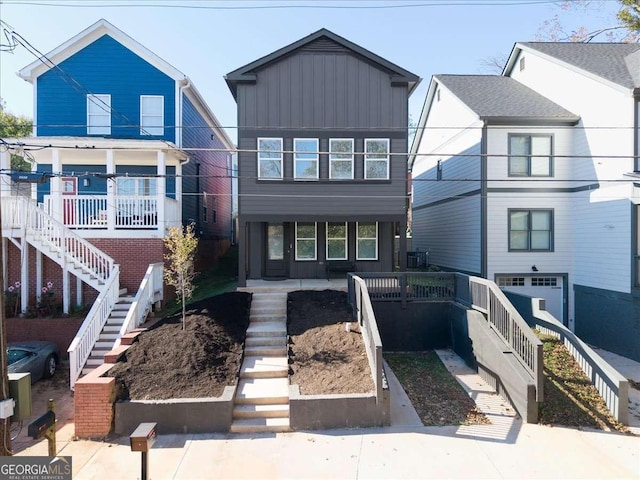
[225,28,420,98]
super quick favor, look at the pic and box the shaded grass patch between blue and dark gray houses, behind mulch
[155,246,238,318]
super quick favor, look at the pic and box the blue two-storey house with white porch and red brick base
[0,20,234,383]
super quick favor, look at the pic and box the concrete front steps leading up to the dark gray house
[231,293,290,433]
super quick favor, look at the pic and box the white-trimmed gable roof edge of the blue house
[18,19,186,83]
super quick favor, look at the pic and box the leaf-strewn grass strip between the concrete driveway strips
[384,351,490,426]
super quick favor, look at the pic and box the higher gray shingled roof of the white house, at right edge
[503,42,640,89]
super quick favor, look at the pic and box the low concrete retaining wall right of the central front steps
[289,385,391,430]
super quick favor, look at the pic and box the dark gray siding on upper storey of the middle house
[237,50,408,221]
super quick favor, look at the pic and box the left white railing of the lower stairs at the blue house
[67,265,120,390]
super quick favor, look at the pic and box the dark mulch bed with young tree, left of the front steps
[108,292,251,400]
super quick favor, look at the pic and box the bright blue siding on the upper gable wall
[36,35,176,142]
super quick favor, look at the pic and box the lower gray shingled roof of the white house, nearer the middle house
[434,75,580,123]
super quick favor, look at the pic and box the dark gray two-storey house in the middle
[226,29,420,285]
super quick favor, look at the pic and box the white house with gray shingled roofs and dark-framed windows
[410,43,640,359]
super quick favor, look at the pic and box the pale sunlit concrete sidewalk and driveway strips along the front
[20,351,640,480]
